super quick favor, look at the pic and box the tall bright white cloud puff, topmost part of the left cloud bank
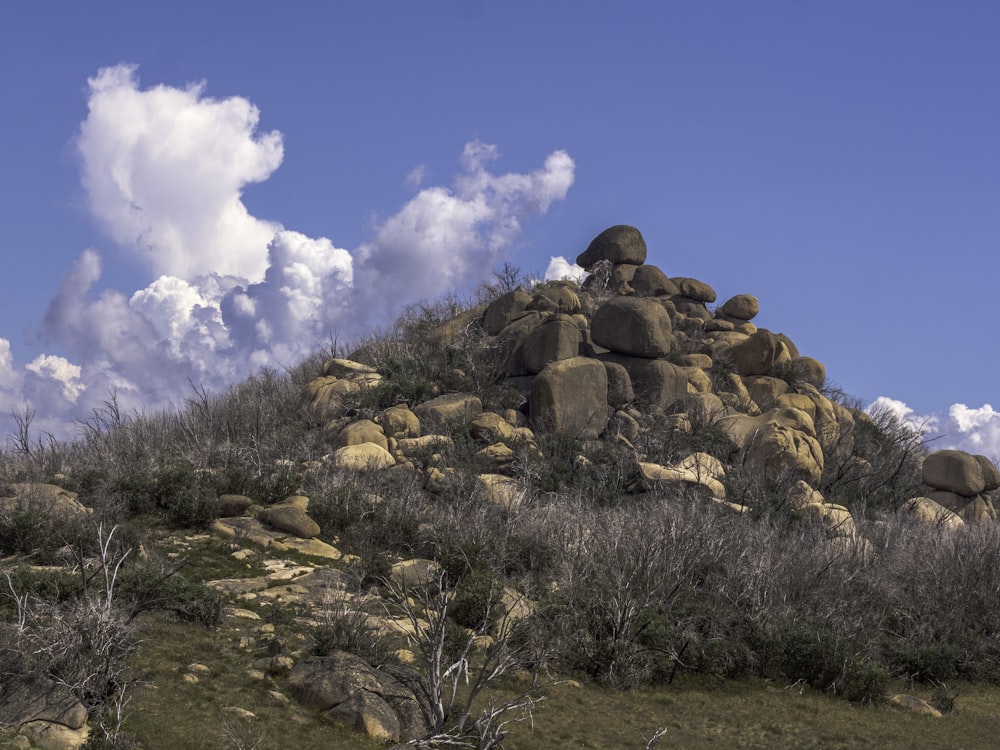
[77,65,283,281]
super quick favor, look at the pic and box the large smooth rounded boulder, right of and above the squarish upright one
[590,297,673,358]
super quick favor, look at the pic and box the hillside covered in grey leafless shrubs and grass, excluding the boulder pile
[0,274,1000,749]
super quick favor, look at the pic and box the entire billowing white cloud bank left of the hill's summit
[0,65,574,434]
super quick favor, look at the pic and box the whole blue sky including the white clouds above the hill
[0,0,1000,456]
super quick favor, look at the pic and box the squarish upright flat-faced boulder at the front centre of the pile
[528,357,609,438]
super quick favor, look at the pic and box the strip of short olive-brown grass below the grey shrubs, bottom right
[506,680,1000,750]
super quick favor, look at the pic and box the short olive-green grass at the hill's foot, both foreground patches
[126,619,1000,750]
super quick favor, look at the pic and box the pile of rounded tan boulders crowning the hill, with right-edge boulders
[304,225,1000,540]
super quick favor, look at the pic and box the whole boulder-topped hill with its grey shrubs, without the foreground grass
[0,225,1000,748]
